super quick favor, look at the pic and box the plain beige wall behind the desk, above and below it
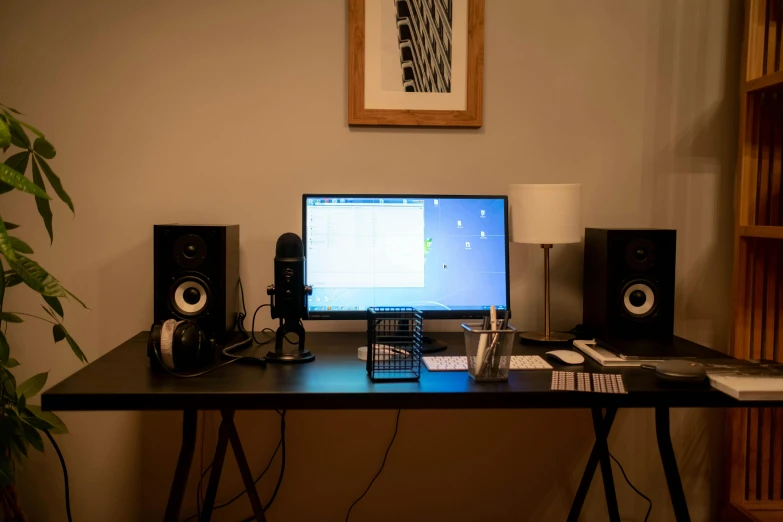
[0,0,741,521]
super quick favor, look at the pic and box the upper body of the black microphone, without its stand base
[272,232,307,321]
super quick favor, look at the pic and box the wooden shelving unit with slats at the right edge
[723,0,783,522]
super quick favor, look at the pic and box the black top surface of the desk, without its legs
[42,332,772,411]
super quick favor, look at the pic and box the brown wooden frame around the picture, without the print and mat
[348,0,484,128]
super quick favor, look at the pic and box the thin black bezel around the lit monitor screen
[302,193,511,321]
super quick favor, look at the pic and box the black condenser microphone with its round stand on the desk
[266,232,315,363]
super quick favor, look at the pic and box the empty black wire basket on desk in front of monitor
[367,307,422,382]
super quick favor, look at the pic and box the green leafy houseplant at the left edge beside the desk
[0,104,87,521]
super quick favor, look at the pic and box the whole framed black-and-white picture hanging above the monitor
[348,0,484,127]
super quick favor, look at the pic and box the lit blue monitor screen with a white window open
[302,194,509,319]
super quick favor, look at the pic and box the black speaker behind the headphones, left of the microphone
[154,225,239,341]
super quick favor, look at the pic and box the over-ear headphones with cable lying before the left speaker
[147,314,266,377]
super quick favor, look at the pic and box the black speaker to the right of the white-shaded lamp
[583,228,677,342]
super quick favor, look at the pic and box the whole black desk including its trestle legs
[41,332,760,522]
